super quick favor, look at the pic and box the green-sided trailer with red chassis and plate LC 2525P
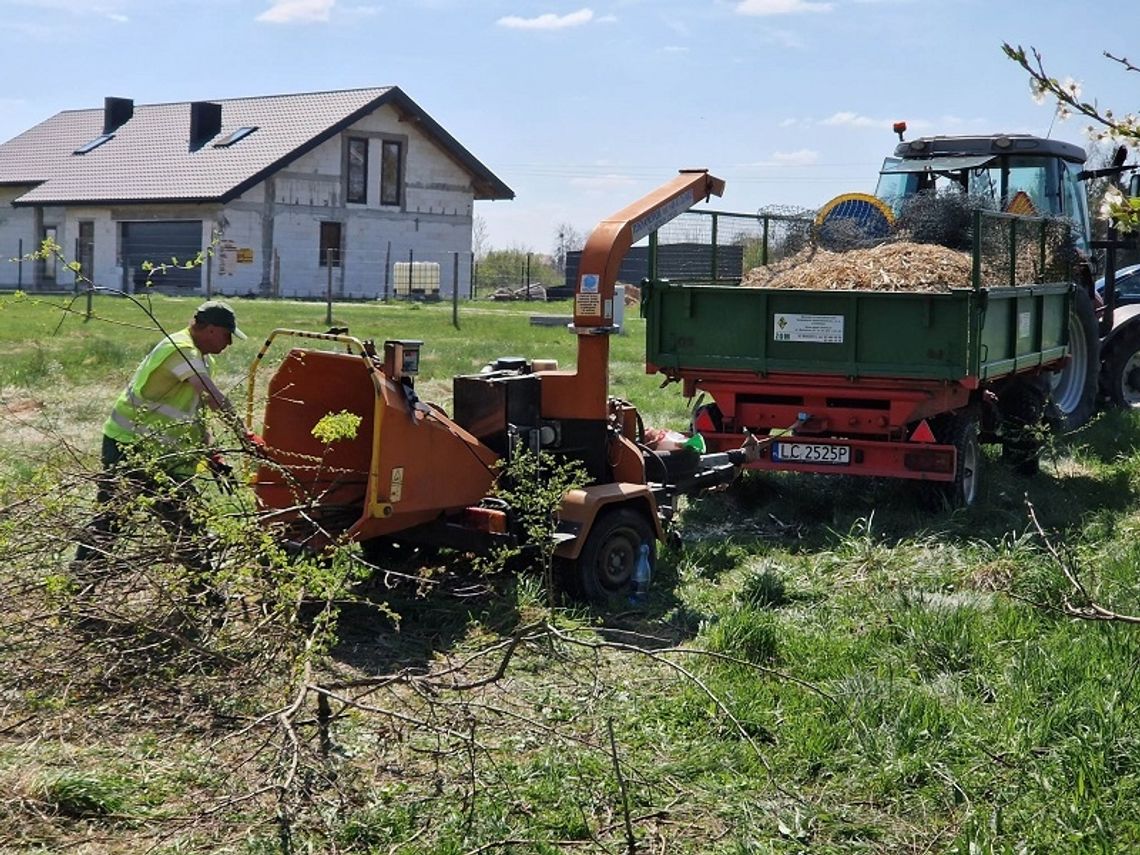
[642,209,1075,504]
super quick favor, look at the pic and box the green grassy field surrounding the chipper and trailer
[0,296,1140,855]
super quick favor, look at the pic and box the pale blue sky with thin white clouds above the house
[0,0,1140,252]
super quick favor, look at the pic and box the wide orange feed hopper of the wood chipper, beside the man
[247,329,498,548]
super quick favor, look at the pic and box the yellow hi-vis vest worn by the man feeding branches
[103,328,213,469]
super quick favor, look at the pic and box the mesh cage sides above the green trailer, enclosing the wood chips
[649,197,1082,291]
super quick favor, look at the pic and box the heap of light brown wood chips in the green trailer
[741,241,971,292]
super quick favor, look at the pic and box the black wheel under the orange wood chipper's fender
[578,507,657,608]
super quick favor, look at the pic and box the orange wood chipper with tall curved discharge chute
[246,170,750,603]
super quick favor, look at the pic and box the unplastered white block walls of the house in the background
[0,101,485,298]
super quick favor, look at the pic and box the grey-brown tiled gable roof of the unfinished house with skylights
[0,87,514,205]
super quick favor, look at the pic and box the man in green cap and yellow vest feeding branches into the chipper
[75,300,245,564]
